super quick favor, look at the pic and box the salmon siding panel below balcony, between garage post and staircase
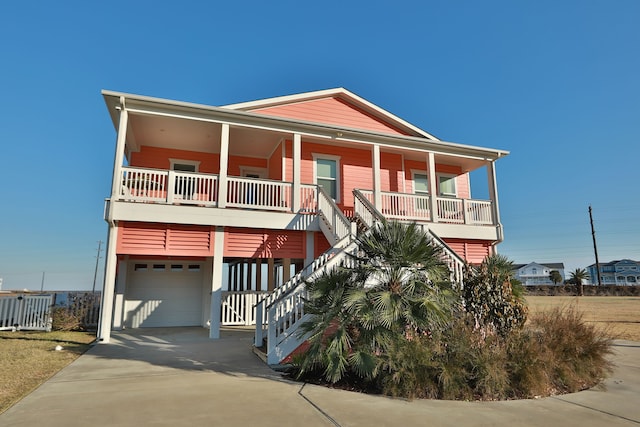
[224,228,305,258]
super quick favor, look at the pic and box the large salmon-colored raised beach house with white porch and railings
[98,88,508,362]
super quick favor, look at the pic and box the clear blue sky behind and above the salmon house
[0,0,640,290]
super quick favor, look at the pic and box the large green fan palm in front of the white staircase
[297,222,453,383]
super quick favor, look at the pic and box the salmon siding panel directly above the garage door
[116,222,214,256]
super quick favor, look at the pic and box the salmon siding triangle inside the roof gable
[252,97,409,135]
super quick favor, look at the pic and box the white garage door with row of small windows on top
[125,262,203,328]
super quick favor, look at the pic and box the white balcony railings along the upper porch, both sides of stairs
[111,167,497,227]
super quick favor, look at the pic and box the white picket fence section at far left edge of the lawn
[0,294,53,331]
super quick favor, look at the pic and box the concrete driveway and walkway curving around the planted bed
[0,328,640,427]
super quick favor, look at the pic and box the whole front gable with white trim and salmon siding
[221,87,439,141]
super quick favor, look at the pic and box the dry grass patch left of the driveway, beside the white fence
[0,331,95,413]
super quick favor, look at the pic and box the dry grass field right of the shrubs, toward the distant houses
[526,296,640,341]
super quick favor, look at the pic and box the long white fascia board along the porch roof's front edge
[102,90,509,160]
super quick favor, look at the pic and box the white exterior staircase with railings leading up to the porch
[254,187,465,366]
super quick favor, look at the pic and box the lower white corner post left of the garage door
[98,224,118,343]
